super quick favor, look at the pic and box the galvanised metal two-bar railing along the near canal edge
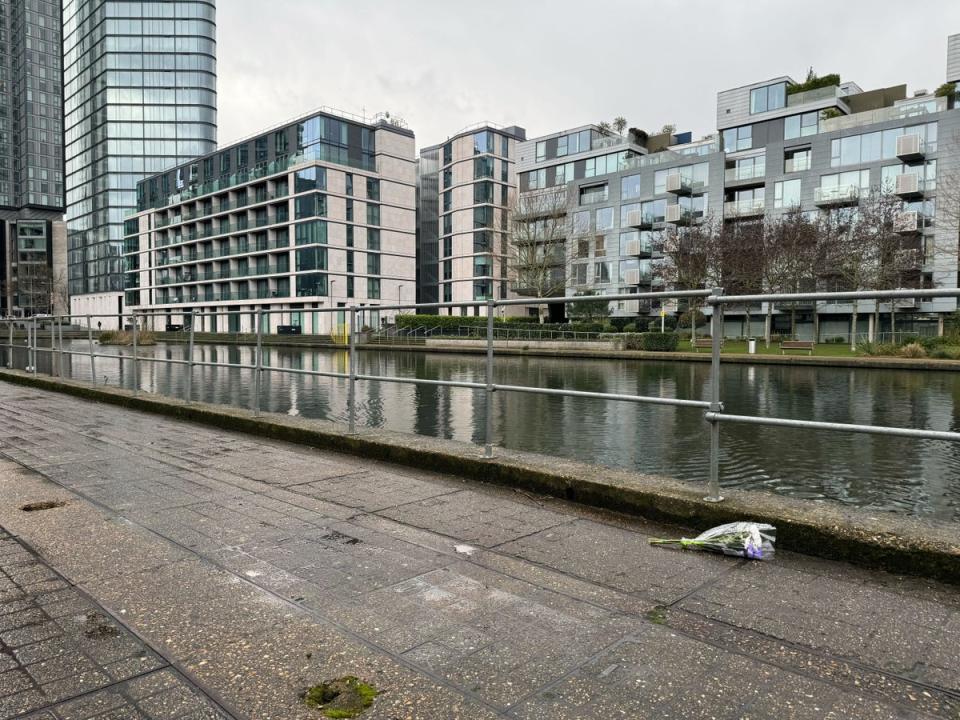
[0,288,960,502]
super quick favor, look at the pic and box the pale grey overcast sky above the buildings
[217,0,960,148]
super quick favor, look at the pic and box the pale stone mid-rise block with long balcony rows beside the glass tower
[125,110,416,334]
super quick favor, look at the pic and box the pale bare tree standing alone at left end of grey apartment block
[505,186,574,322]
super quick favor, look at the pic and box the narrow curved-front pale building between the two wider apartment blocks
[417,122,526,315]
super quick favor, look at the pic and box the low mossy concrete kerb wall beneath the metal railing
[0,370,960,584]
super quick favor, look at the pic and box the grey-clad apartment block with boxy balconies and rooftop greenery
[518,36,960,337]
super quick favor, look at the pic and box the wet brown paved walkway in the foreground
[0,383,960,720]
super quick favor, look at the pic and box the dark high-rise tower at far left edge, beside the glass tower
[0,0,66,316]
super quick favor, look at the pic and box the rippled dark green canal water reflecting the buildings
[0,341,960,521]
